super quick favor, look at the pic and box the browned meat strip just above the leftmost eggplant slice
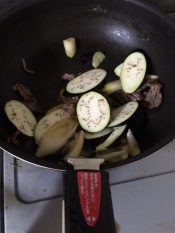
[12,84,41,112]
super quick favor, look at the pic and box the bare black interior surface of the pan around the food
[0,0,175,170]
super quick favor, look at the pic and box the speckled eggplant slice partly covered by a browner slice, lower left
[34,108,70,145]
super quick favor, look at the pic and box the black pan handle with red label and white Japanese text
[63,170,116,233]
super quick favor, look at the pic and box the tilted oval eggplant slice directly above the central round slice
[66,69,106,94]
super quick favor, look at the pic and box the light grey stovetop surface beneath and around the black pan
[0,1,175,233]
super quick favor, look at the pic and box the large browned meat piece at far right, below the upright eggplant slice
[113,79,162,109]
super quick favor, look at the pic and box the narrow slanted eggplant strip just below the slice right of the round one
[96,125,126,151]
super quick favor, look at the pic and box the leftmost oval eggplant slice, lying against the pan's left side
[5,100,37,137]
